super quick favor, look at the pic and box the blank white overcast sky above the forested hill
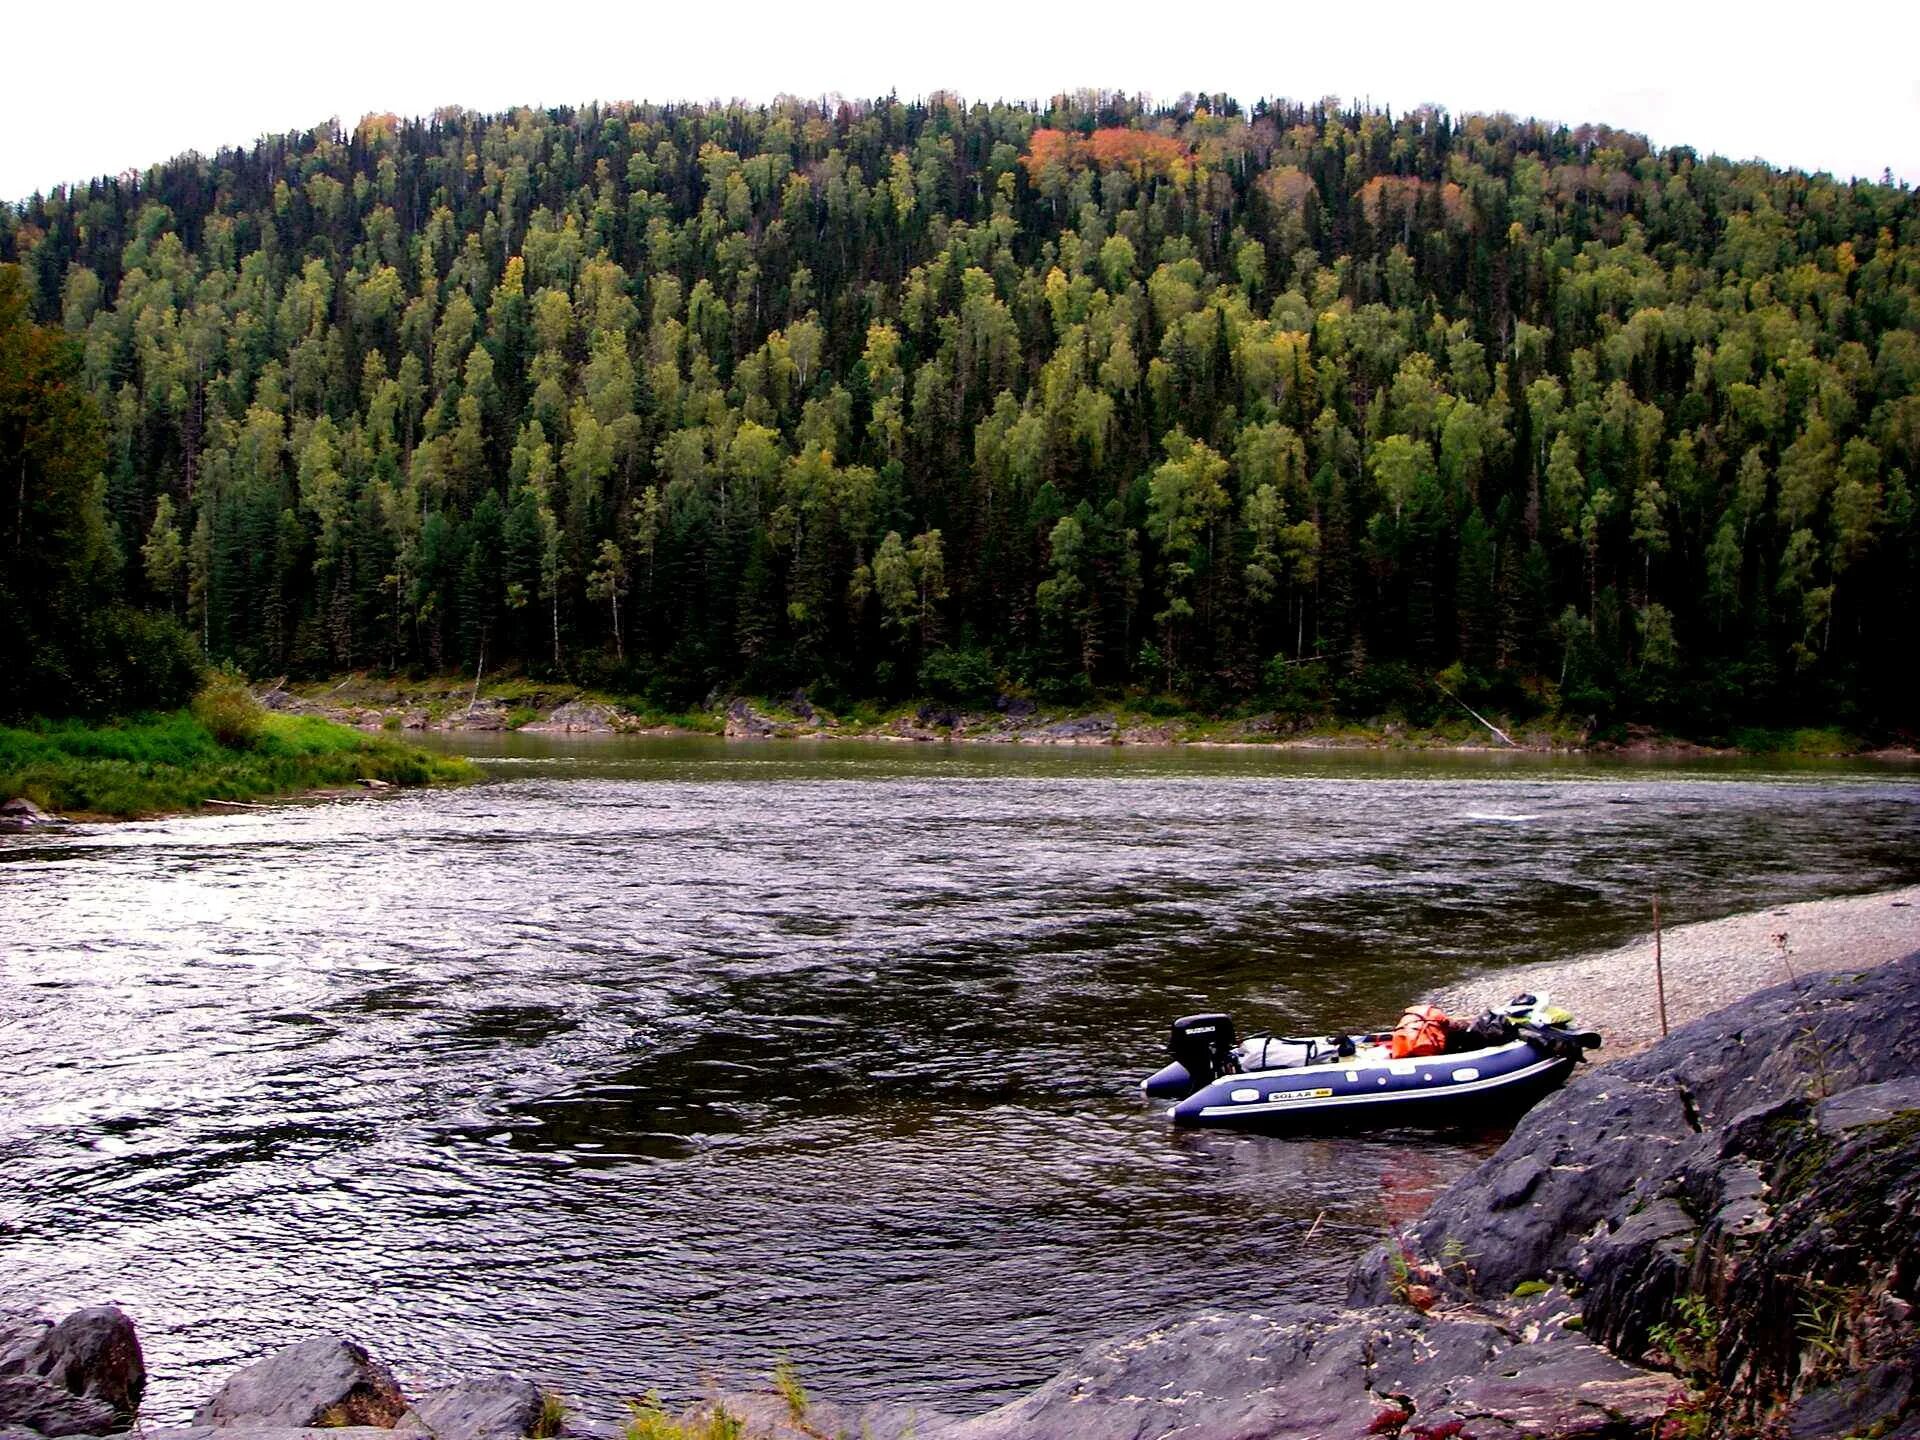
[0,0,1920,198]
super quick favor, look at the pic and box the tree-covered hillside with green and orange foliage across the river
[0,96,1920,733]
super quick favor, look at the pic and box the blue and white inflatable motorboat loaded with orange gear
[1140,996,1599,1131]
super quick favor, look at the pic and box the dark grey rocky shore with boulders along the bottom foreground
[15,952,1920,1440]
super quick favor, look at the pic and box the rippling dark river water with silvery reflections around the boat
[0,737,1920,1421]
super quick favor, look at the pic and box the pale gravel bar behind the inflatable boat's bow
[1432,885,1920,1060]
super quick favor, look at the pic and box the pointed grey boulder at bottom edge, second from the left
[194,1336,407,1430]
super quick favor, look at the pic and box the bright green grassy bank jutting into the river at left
[0,703,476,818]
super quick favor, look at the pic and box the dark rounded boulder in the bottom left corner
[0,1306,146,1436]
